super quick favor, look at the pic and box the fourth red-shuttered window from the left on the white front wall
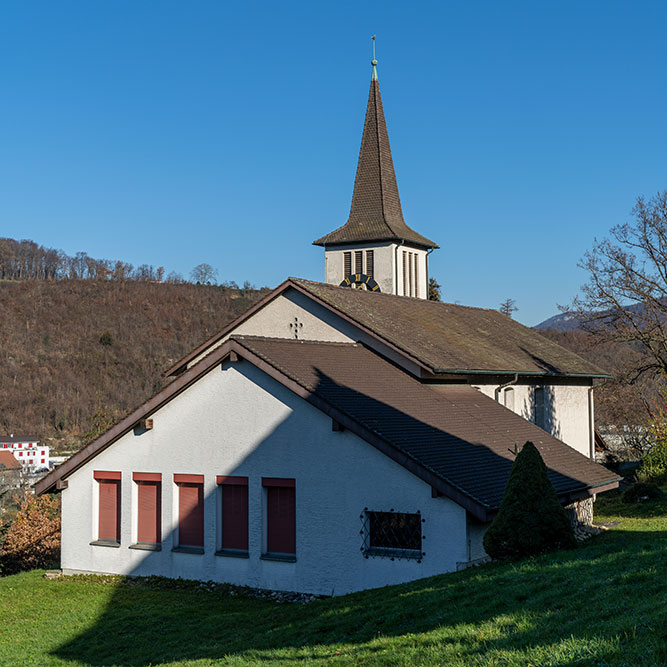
[216,476,248,558]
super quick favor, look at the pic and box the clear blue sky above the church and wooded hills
[0,0,667,325]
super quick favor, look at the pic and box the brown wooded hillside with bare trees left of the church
[0,280,262,446]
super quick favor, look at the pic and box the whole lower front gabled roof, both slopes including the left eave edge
[35,336,618,520]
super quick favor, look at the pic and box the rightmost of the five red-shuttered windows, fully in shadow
[262,477,296,561]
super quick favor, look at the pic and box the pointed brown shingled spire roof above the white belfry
[313,60,438,248]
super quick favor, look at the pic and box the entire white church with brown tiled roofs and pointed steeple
[35,57,618,595]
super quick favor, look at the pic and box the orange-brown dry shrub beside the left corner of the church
[0,495,60,574]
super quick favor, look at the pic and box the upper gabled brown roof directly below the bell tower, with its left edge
[165,278,609,377]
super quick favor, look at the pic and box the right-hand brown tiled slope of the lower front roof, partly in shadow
[232,336,618,512]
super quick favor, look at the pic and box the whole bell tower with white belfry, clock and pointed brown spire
[313,43,438,299]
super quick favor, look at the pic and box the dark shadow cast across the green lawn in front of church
[54,530,667,666]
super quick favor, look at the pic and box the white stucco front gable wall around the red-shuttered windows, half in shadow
[62,362,469,594]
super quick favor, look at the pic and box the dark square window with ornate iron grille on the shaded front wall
[359,507,426,563]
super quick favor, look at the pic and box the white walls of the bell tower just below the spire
[324,243,428,299]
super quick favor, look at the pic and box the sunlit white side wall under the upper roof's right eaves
[475,384,594,457]
